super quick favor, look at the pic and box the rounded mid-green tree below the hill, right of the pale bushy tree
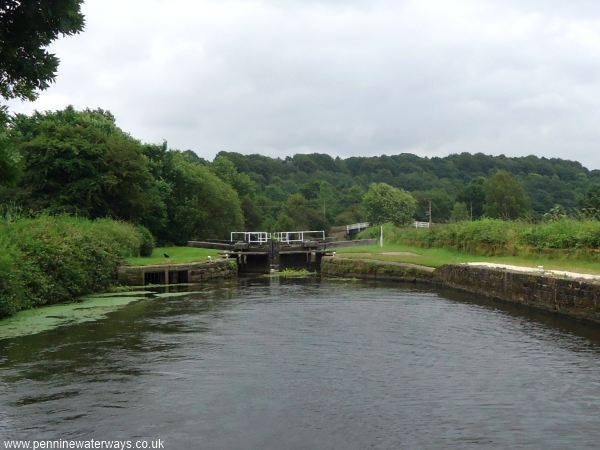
[484,170,531,220]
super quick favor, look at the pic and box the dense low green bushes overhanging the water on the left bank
[0,216,154,317]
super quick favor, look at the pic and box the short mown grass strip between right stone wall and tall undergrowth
[335,244,600,275]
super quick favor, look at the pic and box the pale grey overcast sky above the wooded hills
[11,0,600,169]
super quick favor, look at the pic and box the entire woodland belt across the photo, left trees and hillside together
[0,107,600,243]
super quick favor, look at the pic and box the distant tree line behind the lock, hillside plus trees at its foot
[217,152,600,226]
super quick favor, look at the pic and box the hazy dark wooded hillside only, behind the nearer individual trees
[219,152,598,225]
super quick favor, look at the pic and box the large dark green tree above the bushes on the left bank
[11,107,165,231]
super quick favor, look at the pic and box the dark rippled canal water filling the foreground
[0,278,600,449]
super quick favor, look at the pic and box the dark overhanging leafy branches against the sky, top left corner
[0,0,84,100]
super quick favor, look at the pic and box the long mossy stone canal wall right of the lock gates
[321,256,600,323]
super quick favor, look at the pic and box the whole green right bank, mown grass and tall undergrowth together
[340,219,600,274]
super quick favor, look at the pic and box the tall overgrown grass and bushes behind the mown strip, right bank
[362,219,600,259]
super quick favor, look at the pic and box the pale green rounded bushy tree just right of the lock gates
[362,183,417,225]
